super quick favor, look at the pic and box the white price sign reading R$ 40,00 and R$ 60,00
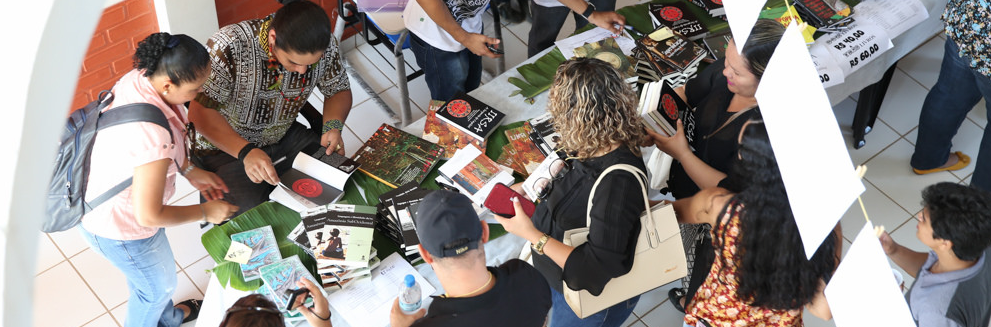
[826,22,892,74]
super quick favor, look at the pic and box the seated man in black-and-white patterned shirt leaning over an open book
[189,0,351,214]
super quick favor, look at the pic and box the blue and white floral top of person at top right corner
[943,0,991,77]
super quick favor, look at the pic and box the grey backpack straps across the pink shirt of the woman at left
[86,104,174,211]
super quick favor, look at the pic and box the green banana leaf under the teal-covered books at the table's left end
[200,202,320,291]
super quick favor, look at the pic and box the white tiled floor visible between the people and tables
[34,10,987,327]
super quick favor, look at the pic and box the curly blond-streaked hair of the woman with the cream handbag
[547,58,645,160]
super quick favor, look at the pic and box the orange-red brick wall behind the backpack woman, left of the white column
[70,0,159,110]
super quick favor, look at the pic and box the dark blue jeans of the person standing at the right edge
[911,39,991,191]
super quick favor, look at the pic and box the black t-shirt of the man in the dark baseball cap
[413,259,551,327]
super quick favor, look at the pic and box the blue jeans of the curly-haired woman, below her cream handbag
[548,287,640,327]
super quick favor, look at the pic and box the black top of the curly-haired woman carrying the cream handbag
[533,146,646,295]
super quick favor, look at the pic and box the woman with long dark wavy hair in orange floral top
[674,121,839,326]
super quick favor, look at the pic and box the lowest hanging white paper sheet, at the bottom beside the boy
[825,223,915,327]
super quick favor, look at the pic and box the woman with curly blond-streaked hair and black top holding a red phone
[496,58,645,327]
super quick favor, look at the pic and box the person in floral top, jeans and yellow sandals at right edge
[911,0,991,191]
